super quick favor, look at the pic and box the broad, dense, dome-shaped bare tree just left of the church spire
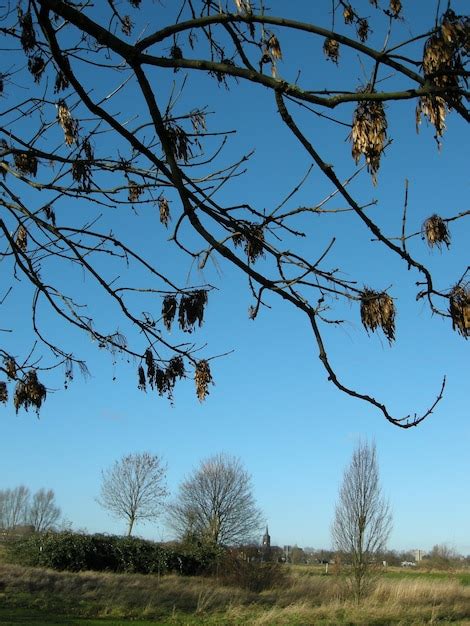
[168,454,263,545]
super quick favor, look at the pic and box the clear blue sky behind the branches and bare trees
[0,0,470,554]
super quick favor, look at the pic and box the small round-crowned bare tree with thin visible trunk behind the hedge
[98,452,168,536]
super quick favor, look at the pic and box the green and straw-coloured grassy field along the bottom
[0,562,470,626]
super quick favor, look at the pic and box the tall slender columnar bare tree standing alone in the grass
[332,443,392,601]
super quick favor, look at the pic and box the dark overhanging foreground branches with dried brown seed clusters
[0,0,470,428]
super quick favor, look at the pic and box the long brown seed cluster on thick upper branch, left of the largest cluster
[349,91,387,185]
